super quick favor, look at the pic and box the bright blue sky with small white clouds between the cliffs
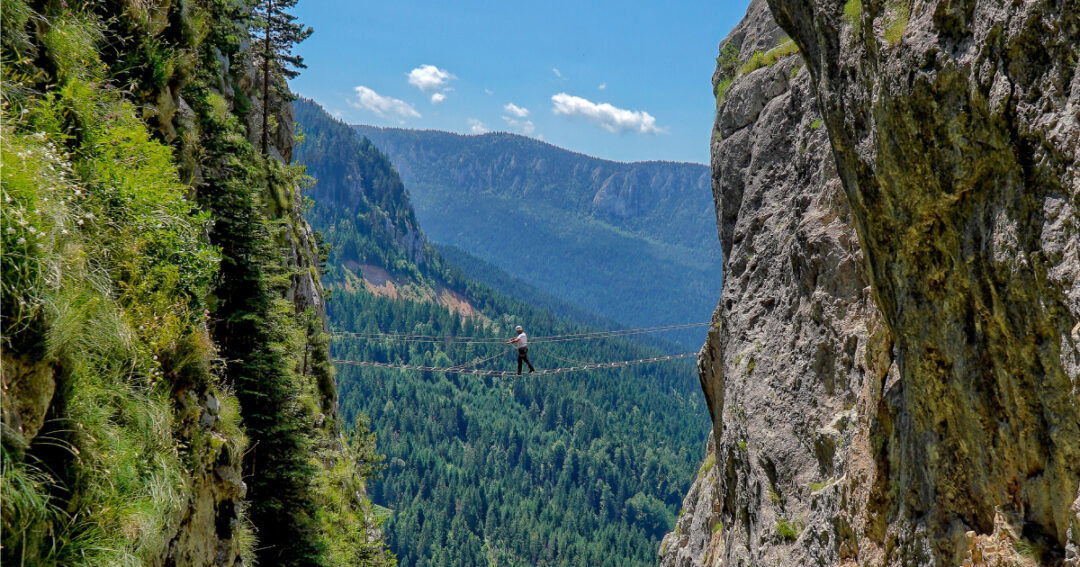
[292,0,748,163]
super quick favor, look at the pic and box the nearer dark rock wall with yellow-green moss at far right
[770,0,1080,565]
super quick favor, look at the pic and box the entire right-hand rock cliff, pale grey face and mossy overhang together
[661,0,1080,566]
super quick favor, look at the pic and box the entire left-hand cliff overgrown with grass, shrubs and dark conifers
[0,0,393,566]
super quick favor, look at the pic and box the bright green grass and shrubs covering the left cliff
[0,6,234,566]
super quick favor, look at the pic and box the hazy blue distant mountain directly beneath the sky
[355,125,721,346]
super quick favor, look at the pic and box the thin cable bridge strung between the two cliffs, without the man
[332,323,711,376]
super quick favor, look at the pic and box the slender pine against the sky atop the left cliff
[252,0,312,154]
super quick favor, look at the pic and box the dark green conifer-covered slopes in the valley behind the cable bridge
[296,100,705,567]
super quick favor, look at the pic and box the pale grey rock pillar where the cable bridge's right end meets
[661,1,890,567]
